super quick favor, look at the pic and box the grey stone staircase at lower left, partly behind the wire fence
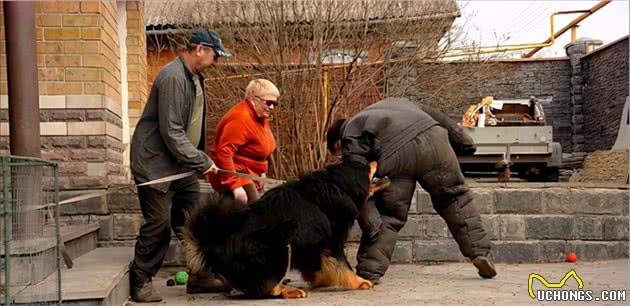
[1,195,133,306]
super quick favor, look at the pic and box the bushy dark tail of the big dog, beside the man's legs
[180,192,247,274]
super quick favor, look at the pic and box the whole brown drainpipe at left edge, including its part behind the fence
[3,1,44,240]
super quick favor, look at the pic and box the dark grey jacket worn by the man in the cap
[131,57,212,191]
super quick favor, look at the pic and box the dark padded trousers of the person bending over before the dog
[357,126,491,277]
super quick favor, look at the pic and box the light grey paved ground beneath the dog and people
[129,259,630,306]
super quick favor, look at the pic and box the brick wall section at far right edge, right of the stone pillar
[581,36,628,152]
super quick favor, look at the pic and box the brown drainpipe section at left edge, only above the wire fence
[3,1,41,157]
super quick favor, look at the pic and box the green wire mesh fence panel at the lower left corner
[0,156,62,305]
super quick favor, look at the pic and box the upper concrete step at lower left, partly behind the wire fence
[0,223,99,287]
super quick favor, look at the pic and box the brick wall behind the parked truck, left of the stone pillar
[400,58,571,152]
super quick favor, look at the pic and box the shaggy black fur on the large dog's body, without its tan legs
[182,160,370,292]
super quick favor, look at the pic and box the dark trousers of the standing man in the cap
[130,176,200,284]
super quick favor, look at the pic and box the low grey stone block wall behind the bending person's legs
[348,185,628,263]
